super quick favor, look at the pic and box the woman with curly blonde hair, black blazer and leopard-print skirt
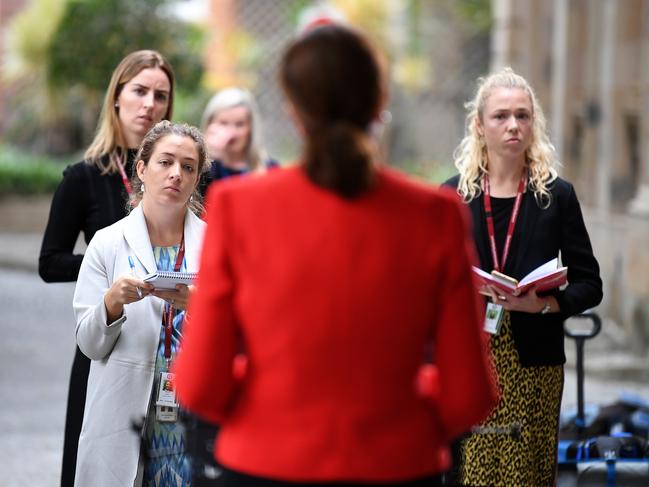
[446,68,602,486]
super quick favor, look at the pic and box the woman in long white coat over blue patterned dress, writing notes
[74,121,207,487]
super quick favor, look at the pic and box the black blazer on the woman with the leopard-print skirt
[444,175,602,367]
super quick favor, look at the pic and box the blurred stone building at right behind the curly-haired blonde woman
[491,0,649,357]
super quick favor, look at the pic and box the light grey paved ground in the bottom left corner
[0,269,74,487]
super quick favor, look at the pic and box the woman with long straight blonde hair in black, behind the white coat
[38,50,175,486]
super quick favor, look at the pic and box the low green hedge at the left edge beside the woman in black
[0,145,66,195]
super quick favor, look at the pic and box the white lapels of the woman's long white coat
[123,206,205,273]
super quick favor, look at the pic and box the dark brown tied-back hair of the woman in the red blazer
[280,24,384,198]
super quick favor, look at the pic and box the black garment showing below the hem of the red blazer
[218,468,442,487]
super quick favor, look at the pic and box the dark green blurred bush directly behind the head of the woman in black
[47,0,202,93]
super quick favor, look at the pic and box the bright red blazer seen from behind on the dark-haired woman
[175,167,495,482]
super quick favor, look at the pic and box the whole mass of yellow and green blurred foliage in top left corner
[0,0,204,154]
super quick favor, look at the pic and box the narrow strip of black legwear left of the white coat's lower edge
[61,347,90,487]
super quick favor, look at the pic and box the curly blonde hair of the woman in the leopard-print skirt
[453,67,559,207]
